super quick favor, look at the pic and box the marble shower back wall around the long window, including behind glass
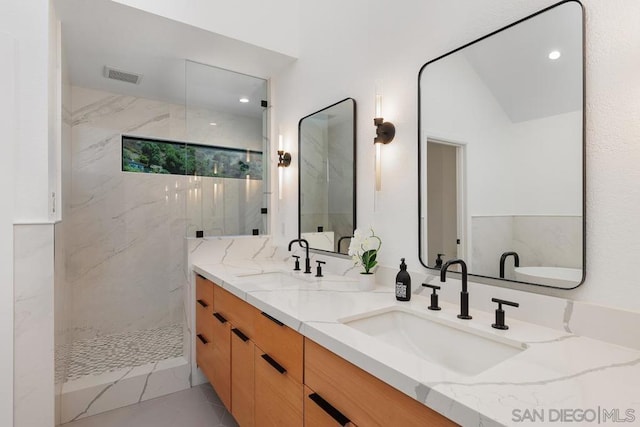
[65,87,265,340]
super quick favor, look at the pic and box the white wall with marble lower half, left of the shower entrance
[0,0,57,427]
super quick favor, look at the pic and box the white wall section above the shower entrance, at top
[113,0,300,56]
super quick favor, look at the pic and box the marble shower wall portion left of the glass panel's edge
[67,87,188,340]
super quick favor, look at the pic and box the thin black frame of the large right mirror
[418,0,587,290]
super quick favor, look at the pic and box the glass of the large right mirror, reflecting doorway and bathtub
[419,1,585,289]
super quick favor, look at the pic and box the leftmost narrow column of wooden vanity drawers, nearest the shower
[196,275,213,381]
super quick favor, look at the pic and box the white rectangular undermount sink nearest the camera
[340,307,526,376]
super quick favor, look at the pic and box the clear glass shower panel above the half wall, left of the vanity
[185,61,269,237]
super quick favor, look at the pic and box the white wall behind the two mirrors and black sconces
[272,0,640,310]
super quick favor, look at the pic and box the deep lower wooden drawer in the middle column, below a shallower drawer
[254,346,303,427]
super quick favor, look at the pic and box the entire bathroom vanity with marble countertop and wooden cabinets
[191,237,640,426]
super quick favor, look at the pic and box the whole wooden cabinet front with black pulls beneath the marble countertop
[196,275,456,427]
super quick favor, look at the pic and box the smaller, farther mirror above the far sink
[298,98,356,254]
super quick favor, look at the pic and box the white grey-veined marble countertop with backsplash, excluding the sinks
[190,241,640,426]
